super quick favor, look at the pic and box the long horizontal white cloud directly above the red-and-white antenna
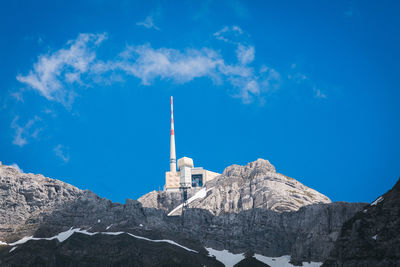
[95,45,280,103]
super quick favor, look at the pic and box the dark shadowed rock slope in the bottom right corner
[323,179,400,267]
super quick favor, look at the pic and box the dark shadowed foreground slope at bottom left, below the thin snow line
[0,233,223,267]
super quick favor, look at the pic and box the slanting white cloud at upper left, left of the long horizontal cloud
[17,34,107,105]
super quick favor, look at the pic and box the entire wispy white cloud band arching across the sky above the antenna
[17,26,280,105]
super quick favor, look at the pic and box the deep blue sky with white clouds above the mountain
[0,1,400,203]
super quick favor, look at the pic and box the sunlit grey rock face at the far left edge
[0,164,85,243]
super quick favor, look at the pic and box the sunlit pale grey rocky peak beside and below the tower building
[138,159,331,215]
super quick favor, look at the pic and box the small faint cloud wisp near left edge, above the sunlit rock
[11,116,41,147]
